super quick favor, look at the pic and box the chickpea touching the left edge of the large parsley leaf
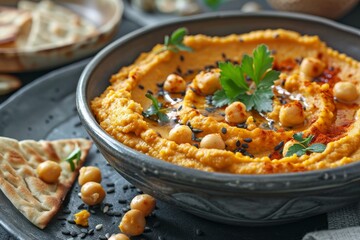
[195,71,221,95]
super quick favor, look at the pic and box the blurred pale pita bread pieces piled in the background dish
[0,0,97,51]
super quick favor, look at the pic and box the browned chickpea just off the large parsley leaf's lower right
[279,101,305,127]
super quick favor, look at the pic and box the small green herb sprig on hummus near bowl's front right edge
[285,132,326,157]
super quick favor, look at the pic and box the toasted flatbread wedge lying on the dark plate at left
[0,137,92,229]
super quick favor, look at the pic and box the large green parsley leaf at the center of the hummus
[212,44,280,112]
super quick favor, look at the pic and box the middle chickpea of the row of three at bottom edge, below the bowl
[119,209,146,236]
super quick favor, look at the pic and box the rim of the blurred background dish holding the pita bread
[0,0,124,55]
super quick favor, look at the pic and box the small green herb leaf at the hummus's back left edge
[164,28,192,53]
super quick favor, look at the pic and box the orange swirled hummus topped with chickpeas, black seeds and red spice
[91,29,360,174]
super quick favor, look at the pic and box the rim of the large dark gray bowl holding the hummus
[76,11,360,194]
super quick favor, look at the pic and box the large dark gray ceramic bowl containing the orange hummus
[77,12,360,225]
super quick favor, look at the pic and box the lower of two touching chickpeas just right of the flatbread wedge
[81,182,106,206]
